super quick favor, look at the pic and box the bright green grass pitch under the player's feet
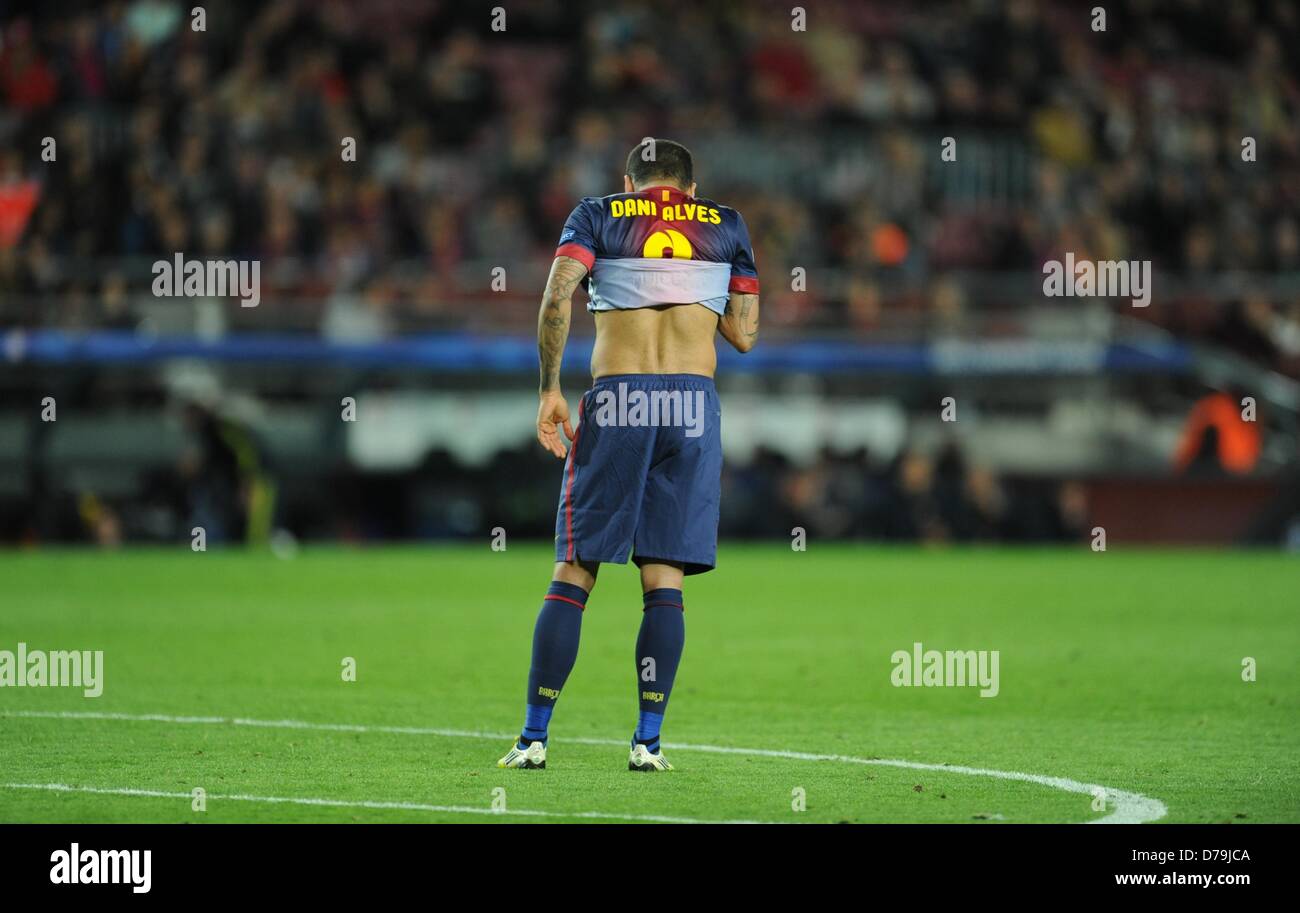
[0,544,1300,822]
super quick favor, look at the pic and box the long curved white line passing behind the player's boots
[0,710,1169,825]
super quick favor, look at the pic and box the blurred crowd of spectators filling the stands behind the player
[0,0,1300,371]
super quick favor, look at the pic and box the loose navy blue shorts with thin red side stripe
[555,375,723,574]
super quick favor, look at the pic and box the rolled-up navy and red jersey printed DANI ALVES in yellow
[555,187,758,315]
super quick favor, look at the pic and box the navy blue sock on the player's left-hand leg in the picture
[520,580,586,748]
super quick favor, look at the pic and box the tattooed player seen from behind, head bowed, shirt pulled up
[498,139,758,771]
